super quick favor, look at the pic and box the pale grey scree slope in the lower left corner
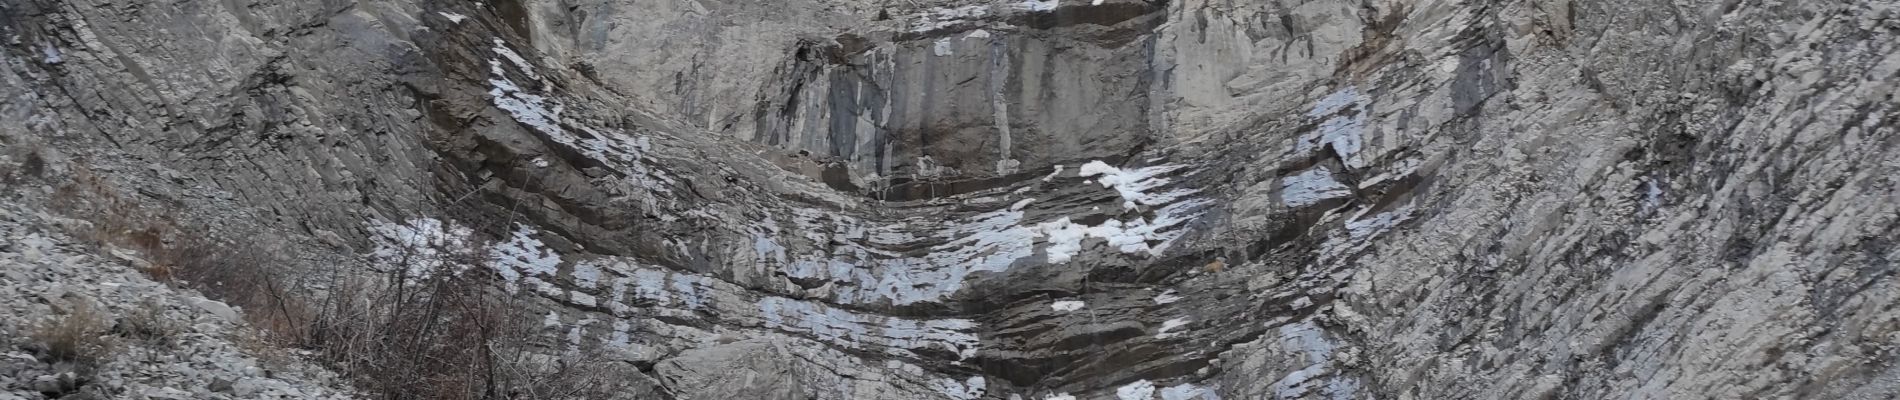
[0,203,357,400]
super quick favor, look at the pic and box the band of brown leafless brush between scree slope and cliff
[42,167,633,400]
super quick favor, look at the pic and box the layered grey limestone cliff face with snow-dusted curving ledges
[0,0,1900,400]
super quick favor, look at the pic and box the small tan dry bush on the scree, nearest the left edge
[30,301,114,366]
